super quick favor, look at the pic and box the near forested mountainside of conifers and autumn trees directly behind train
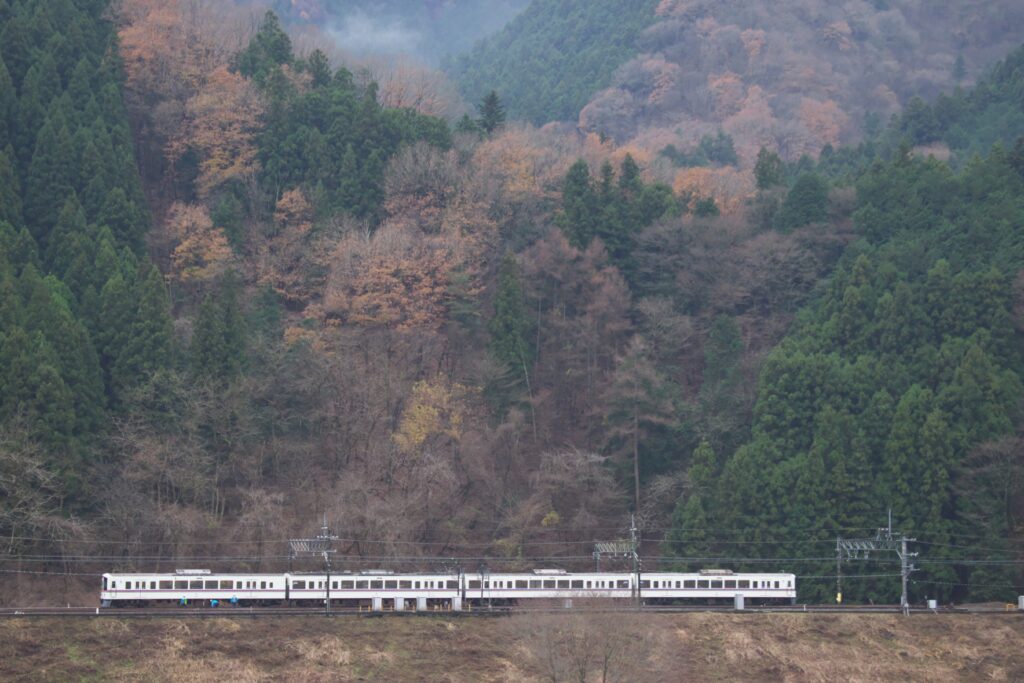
[0,0,1024,601]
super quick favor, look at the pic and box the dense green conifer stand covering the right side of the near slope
[691,148,1024,600]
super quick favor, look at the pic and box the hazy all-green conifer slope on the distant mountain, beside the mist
[446,0,657,124]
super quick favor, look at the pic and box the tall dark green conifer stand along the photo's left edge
[0,0,159,507]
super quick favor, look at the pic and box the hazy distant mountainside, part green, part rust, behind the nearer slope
[450,0,1024,160]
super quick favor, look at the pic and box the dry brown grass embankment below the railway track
[0,613,1024,683]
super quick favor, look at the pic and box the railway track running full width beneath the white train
[0,605,1024,618]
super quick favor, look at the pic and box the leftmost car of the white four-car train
[99,569,287,607]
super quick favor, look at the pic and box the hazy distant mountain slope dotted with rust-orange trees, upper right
[581,0,1024,163]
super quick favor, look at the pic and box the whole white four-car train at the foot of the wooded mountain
[100,569,797,611]
